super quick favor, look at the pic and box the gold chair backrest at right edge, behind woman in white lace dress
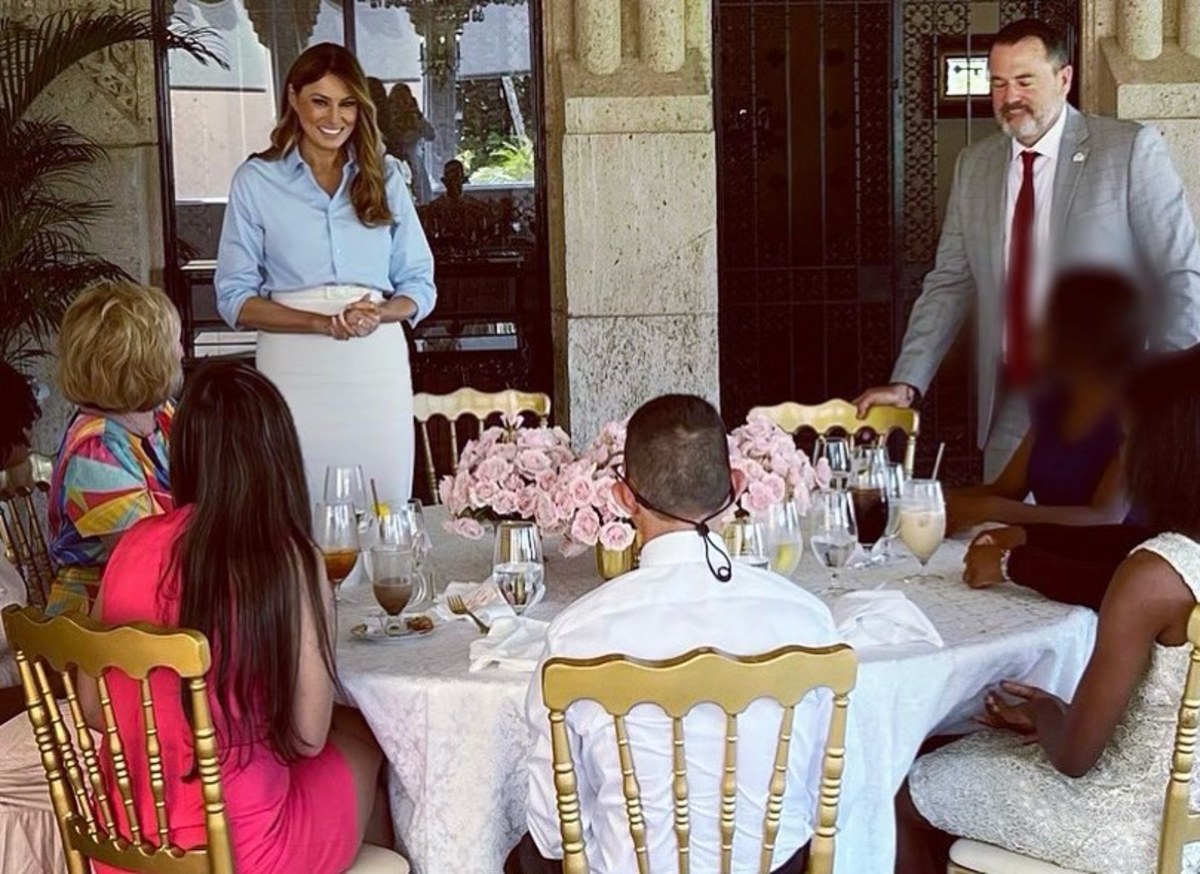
[1158,605,1200,874]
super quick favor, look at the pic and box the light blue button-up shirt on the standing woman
[215,149,438,328]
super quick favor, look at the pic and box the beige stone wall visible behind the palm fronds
[0,0,162,451]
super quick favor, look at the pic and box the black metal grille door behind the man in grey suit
[715,0,1078,481]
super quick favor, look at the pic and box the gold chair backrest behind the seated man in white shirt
[541,645,858,874]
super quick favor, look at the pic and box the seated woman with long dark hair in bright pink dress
[80,363,390,874]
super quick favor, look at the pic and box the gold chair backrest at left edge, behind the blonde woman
[0,453,54,606]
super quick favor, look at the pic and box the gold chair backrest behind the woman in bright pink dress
[2,606,233,874]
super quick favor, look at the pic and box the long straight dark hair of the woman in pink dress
[170,361,336,761]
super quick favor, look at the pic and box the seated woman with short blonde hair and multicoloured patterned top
[47,282,184,615]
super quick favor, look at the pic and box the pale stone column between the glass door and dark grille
[545,0,720,445]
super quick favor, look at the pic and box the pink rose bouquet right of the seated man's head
[730,415,830,516]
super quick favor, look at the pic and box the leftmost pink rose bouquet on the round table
[438,415,575,540]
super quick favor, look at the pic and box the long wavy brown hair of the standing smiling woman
[254,42,392,227]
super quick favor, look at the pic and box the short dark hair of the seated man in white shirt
[625,395,731,520]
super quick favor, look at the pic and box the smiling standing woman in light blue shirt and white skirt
[216,42,437,499]
